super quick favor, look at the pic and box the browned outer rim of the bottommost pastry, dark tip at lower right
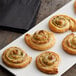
[36,51,61,74]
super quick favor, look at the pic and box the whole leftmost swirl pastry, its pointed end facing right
[2,47,32,68]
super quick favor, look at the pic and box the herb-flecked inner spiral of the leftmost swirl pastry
[5,48,27,63]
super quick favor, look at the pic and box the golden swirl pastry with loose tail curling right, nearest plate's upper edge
[49,15,76,33]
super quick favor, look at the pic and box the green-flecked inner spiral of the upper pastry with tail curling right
[52,15,73,28]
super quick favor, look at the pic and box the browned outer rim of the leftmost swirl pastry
[2,47,32,68]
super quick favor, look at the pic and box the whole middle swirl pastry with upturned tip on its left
[25,30,55,50]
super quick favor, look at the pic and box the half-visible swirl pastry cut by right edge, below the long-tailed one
[62,33,76,55]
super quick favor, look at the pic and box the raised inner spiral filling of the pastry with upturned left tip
[31,30,50,44]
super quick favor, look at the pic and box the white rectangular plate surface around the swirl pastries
[0,0,76,76]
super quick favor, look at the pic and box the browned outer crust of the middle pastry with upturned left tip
[24,33,56,51]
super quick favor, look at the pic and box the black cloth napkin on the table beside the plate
[0,0,40,33]
